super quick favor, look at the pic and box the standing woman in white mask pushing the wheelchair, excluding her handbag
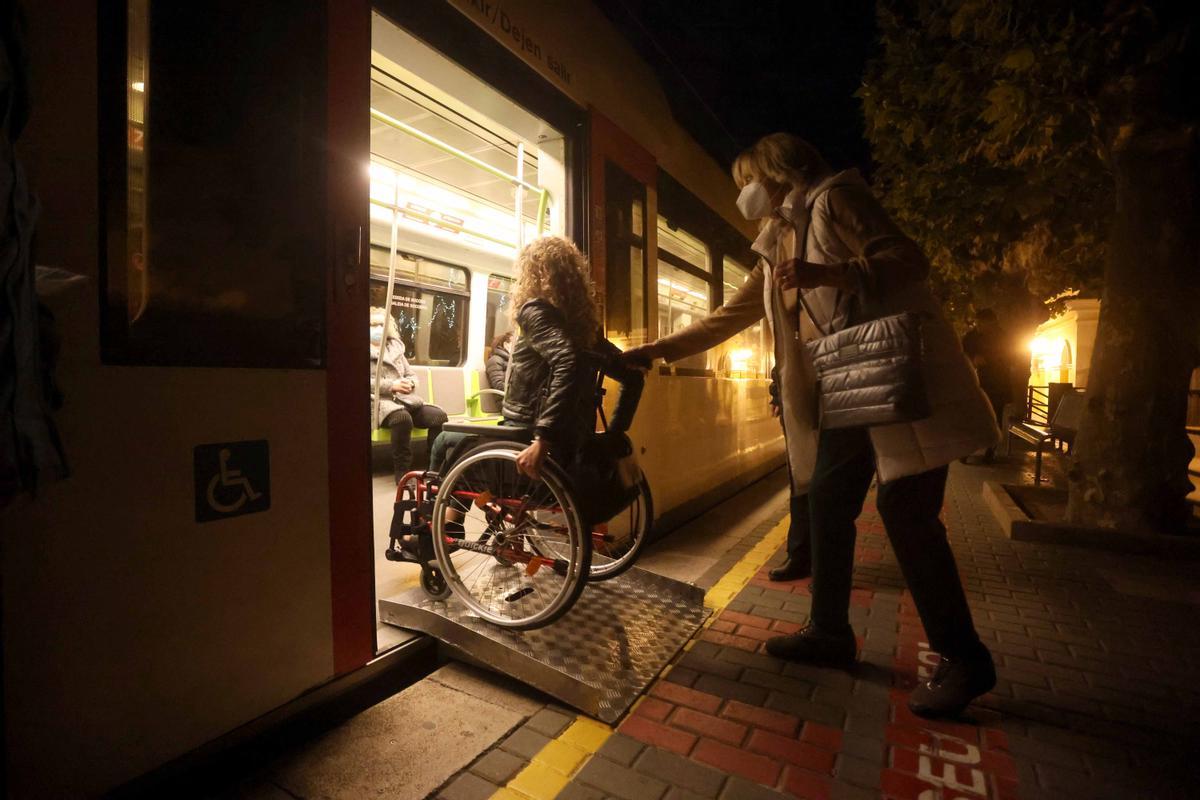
[629,133,998,716]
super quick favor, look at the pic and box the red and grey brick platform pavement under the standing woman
[439,465,1200,800]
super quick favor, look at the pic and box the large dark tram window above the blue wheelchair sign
[100,0,326,367]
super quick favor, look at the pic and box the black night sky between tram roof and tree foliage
[598,0,875,173]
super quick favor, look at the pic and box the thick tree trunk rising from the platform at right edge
[1067,126,1200,534]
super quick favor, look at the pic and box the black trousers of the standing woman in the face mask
[808,428,983,657]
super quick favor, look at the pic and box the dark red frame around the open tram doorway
[325,0,588,674]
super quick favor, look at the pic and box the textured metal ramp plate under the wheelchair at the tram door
[379,569,710,722]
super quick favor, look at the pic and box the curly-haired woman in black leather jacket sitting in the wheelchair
[430,236,644,477]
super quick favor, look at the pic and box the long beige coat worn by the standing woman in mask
[656,170,1000,493]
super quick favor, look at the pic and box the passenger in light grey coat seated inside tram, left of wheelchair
[371,308,448,483]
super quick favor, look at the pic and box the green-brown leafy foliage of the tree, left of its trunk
[858,0,1114,318]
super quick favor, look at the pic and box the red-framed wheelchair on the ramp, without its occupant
[385,379,654,630]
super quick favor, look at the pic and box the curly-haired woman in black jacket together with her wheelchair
[388,236,653,628]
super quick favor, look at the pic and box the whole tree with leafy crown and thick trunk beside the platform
[859,0,1200,533]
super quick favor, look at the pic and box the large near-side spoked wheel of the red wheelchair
[433,441,592,628]
